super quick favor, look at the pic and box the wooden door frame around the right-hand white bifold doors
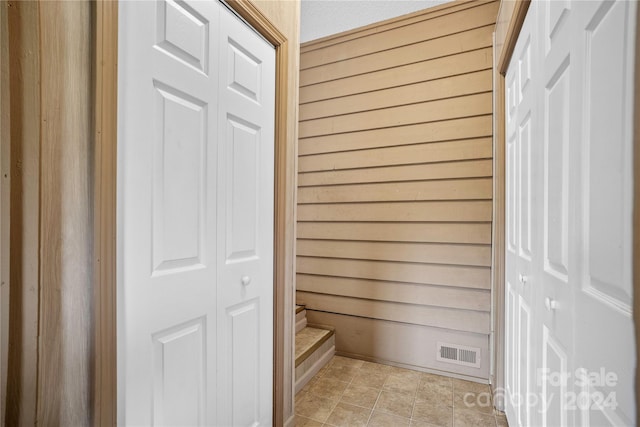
[491,0,640,424]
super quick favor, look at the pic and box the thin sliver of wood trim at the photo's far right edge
[631,2,640,425]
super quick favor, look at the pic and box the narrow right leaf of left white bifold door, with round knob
[218,6,275,426]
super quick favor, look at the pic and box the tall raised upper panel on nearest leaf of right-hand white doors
[583,2,633,313]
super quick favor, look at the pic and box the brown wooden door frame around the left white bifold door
[93,0,292,426]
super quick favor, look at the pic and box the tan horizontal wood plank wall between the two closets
[297,0,498,377]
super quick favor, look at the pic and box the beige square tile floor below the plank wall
[295,356,507,427]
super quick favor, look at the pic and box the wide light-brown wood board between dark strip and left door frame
[37,1,94,425]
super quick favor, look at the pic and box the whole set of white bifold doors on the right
[505,0,637,426]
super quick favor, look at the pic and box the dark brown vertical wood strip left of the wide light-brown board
[5,1,40,425]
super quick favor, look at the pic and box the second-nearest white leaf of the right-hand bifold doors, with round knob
[536,0,580,426]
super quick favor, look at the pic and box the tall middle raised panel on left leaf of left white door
[152,81,209,274]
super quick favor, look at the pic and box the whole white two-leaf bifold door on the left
[117,0,275,426]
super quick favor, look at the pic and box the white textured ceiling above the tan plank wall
[300,0,451,43]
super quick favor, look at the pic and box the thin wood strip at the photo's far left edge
[0,0,11,426]
